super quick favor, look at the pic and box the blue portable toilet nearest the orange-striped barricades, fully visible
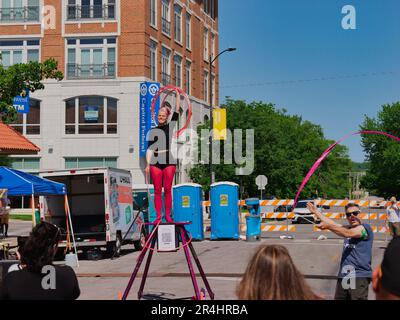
[210,182,239,240]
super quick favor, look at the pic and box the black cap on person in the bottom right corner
[381,237,400,297]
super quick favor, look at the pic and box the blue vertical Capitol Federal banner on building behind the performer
[139,82,160,157]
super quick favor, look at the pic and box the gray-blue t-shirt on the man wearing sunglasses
[338,224,374,278]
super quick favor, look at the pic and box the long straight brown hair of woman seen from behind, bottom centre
[237,245,319,300]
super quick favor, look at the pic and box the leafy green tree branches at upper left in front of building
[0,59,63,122]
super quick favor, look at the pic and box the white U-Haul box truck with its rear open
[40,168,145,255]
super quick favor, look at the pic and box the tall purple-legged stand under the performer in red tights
[122,222,214,300]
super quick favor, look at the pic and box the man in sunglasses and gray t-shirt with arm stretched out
[307,203,374,300]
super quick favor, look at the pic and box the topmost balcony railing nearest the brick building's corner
[67,4,115,20]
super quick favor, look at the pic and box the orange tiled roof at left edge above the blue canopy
[0,122,40,155]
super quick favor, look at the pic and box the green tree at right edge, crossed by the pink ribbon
[361,102,400,198]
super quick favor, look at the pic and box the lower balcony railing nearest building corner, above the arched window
[67,62,115,79]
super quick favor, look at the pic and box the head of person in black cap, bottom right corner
[372,237,400,300]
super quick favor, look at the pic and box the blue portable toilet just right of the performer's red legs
[173,183,204,241]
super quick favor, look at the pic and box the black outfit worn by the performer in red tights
[147,112,179,167]
